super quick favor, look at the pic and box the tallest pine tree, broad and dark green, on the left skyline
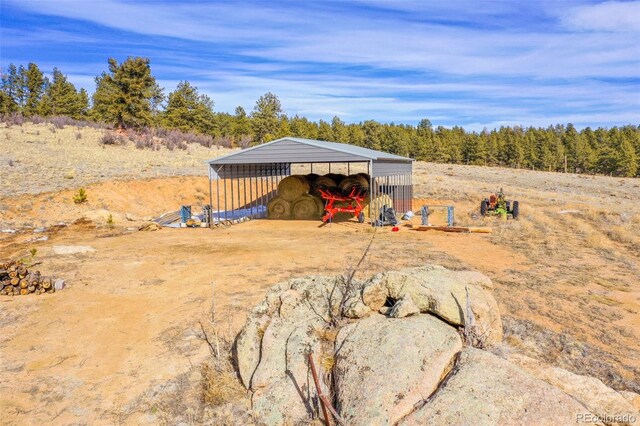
[92,57,164,128]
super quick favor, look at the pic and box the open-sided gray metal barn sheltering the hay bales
[208,137,414,222]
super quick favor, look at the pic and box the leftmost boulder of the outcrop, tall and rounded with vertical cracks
[236,277,339,425]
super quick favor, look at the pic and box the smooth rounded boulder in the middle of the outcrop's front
[334,314,462,425]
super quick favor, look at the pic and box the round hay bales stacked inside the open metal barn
[267,173,393,220]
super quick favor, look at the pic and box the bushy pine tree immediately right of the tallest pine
[163,81,214,133]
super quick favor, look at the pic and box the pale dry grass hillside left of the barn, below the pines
[0,123,231,197]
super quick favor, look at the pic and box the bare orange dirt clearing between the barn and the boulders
[0,221,519,425]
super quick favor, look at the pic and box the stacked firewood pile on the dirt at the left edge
[0,260,56,296]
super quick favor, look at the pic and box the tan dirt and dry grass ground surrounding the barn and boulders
[0,125,640,425]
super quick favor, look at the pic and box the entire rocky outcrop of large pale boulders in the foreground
[231,265,640,425]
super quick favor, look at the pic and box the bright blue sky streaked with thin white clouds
[0,0,640,130]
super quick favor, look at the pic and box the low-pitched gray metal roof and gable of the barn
[208,137,413,165]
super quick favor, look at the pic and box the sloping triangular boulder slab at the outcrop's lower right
[400,348,588,426]
